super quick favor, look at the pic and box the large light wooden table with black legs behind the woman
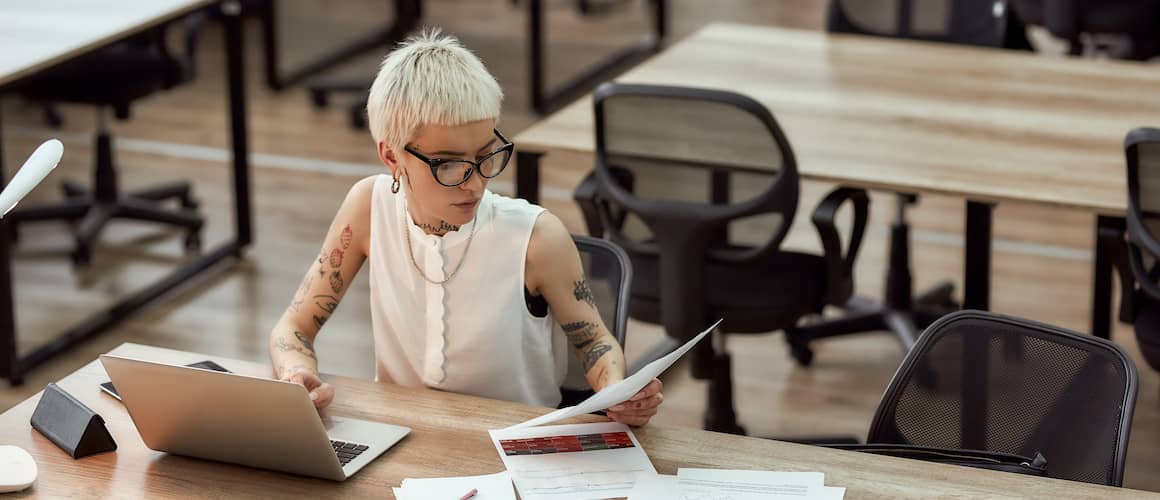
[515,23,1160,338]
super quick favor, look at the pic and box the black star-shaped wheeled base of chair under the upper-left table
[7,181,205,266]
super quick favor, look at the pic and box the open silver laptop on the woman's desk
[101,355,411,481]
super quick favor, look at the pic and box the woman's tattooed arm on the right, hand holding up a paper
[525,212,664,426]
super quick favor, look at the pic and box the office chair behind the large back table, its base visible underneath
[826,0,1008,347]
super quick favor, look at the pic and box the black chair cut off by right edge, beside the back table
[1117,129,1160,370]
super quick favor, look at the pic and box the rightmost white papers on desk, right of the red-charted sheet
[629,469,846,500]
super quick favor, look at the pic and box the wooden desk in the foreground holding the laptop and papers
[0,343,1158,499]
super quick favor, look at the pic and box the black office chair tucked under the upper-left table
[7,13,204,265]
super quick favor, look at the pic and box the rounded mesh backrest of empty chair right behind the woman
[595,84,798,338]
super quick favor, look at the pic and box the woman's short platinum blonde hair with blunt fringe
[367,29,503,152]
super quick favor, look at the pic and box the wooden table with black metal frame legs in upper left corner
[0,0,253,384]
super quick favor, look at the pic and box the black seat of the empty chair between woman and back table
[629,252,826,333]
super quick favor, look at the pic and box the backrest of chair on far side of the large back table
[826,0,1007,48]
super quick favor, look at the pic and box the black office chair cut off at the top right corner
[1012,0,1160,60]
